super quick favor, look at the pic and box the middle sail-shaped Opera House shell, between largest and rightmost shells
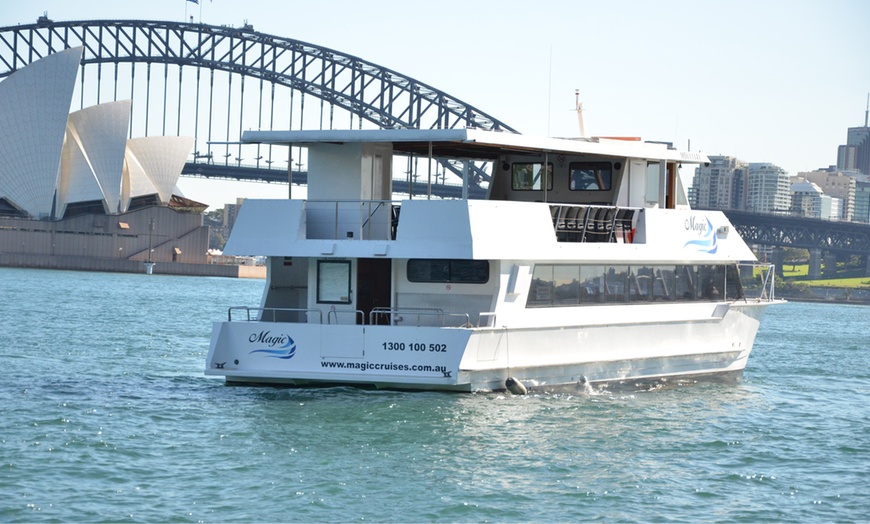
[57,100,133,216]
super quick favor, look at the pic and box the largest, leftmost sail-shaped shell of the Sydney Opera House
[0,47,83,218]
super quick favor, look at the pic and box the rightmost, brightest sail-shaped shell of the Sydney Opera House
[122,136,194,209]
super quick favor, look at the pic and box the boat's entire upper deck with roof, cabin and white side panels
[227,129,754,261]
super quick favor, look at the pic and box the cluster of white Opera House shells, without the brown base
[0,48,199,220]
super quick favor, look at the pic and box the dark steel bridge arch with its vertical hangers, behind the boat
[0,17,516,184]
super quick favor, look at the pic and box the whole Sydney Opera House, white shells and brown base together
[0,48,250,276]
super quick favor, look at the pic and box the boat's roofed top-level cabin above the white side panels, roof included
[242,129,709,209]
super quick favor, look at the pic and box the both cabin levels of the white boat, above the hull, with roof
[226,129,751,325]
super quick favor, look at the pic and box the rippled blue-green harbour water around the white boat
[0,268,870,522]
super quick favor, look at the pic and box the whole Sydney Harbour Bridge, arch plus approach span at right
[0,16,870,269]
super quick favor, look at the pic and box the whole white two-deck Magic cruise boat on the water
[205,129,776,392]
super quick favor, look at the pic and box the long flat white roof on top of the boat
[242,128,710,163]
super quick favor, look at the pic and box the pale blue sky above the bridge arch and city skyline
[0,0,870,207]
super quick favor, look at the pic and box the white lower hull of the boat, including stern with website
[206,302,768,391]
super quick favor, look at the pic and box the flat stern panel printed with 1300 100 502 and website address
[205,322,472,390]
